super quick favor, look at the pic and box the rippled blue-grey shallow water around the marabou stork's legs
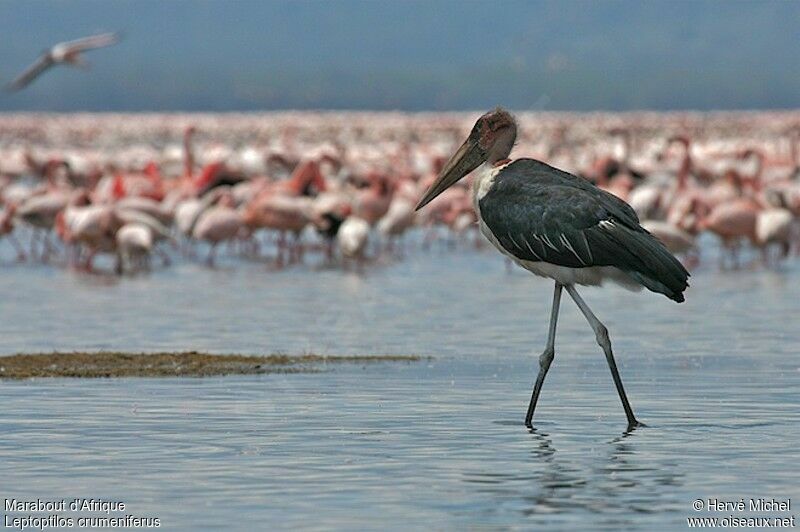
[0,239,800,530]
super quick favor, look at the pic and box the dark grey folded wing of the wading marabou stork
[479,163,689,301]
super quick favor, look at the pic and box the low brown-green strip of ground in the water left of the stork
[0,351,423,380]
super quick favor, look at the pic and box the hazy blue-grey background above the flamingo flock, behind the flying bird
[0,0,800,112]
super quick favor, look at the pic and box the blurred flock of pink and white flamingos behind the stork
[0,112,800,274]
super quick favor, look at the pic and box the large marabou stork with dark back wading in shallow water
[417,108,689,430]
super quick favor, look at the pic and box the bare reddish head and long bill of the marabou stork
[417,107,517,210]
